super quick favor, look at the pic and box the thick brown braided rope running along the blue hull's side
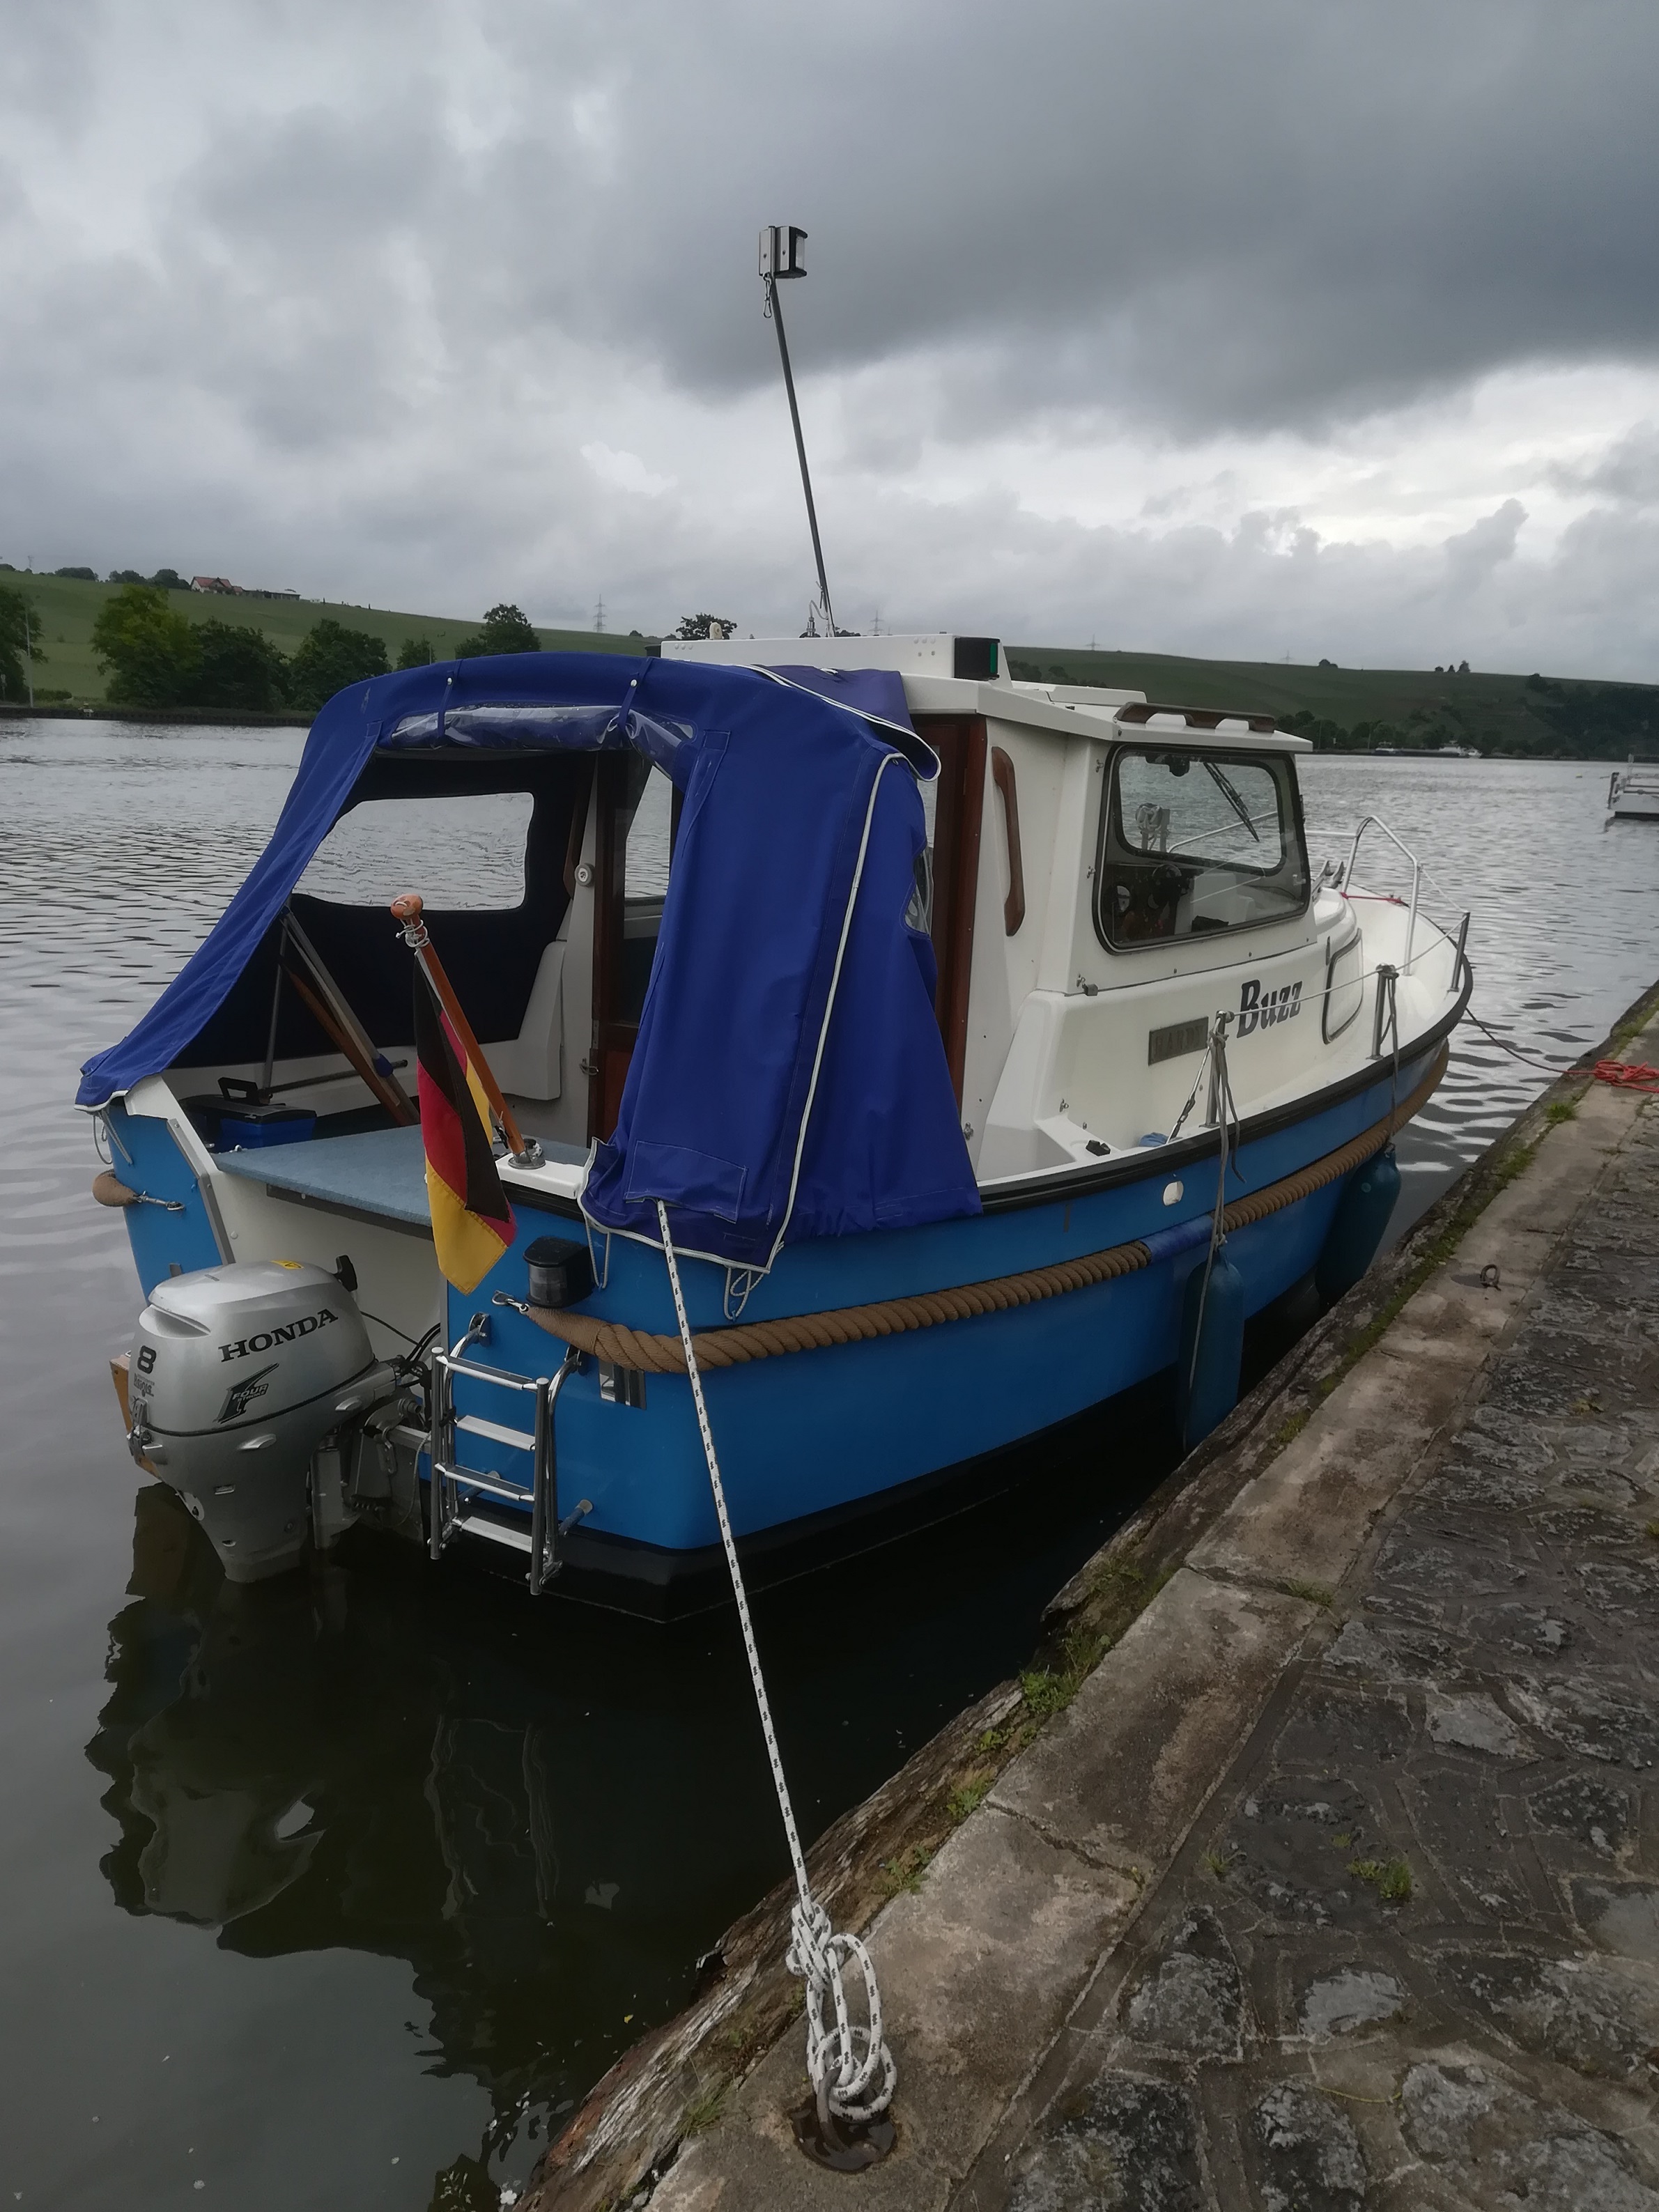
[529,1046,1449,1376]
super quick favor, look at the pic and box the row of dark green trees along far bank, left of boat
[84,584,542,715]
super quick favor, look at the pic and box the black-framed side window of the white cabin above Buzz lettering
[1095,745,1307,951]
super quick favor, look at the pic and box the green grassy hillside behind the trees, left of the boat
[0,569,642,704]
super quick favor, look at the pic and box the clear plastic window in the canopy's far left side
[299,792,535,913]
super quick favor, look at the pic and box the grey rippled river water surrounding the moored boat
[0,723,1659,2212]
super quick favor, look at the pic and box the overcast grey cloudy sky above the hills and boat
[0,0,1659,681]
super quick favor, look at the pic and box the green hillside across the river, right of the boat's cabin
[1009,646,1659,761]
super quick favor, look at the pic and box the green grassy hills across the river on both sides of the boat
[0,571,1659,759]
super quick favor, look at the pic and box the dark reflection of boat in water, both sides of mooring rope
[86,1391,1170,2203]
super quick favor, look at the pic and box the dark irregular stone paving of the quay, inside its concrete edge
[973,1092,1659,2212]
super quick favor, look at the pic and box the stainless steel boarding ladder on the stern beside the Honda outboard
[427,1314,593,1597]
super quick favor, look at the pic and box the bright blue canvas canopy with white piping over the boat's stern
[79,653,980,1267]
